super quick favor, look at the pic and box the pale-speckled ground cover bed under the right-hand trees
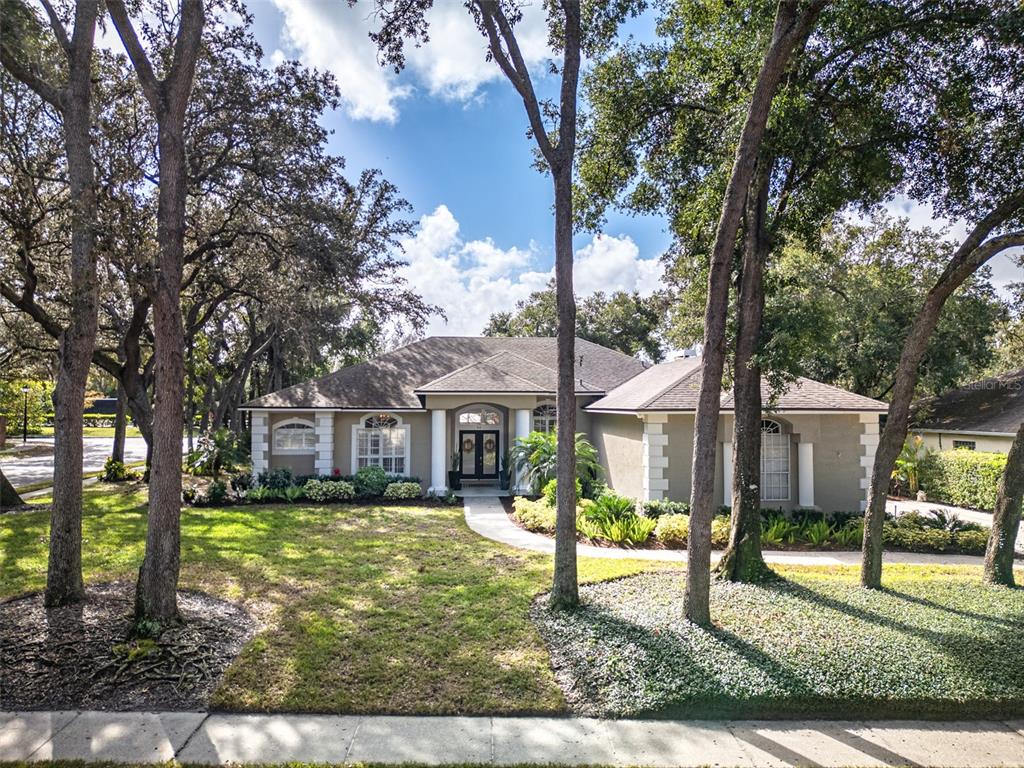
[532,566,1024,718]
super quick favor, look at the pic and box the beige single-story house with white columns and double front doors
[243,337,886,511]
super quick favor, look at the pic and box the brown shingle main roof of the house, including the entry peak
[244,336,644,410]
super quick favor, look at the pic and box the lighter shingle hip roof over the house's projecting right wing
[587,357,888,412]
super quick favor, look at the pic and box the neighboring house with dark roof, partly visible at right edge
[911,369,1024,454]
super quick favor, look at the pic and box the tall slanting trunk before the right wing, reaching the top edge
[684,0,825,626]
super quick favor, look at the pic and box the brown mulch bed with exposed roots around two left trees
[0,582,257,711]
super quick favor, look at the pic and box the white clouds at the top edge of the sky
[273,0,551,123]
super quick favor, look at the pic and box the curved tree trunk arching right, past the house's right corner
[860,202,1024,589]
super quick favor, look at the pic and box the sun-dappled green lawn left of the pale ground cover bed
[0,484,663,714]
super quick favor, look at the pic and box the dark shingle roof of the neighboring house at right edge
[914,369,1024,434]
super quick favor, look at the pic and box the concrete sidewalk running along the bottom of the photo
[0,712,1024,768]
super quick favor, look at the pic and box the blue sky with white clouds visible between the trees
[224,0,1020,334]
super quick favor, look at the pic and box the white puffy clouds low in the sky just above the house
[402,205,662,336]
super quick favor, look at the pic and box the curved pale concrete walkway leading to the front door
[466,497,984,565]
